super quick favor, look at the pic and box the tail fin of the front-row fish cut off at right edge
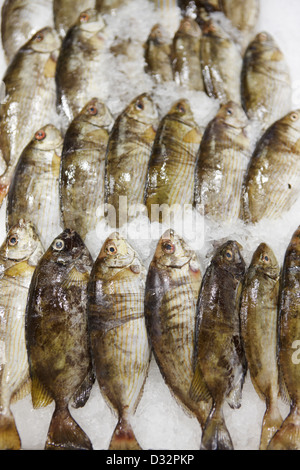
[268,408,300,450]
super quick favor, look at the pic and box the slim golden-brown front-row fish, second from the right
[240,243,283,450]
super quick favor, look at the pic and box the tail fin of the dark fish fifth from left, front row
[201,409,233,450]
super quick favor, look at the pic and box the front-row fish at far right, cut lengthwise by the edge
[268,226,300,450]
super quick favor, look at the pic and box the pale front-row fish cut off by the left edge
[0,219,44,450]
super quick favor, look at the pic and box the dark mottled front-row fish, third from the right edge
[190,240,247,450]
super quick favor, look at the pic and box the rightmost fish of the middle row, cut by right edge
[241,110,300,223]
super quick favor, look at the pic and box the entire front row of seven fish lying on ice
[0,220,300,450]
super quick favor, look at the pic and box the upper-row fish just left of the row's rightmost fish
[200,20,243,104]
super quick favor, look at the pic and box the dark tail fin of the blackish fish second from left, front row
[45,407,93,450]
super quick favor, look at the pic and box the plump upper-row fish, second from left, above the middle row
[56,9,106,127]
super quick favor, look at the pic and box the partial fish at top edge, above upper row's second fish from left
[53,0,95,38]
